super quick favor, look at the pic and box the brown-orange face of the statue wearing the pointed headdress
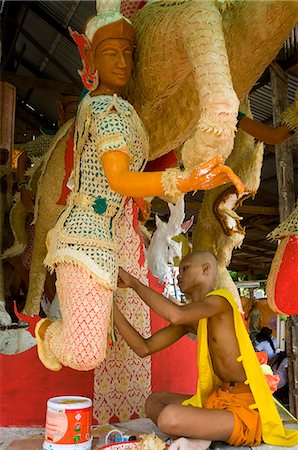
[93,39,133,94]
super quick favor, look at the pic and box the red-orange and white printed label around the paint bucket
[45,406,92,444]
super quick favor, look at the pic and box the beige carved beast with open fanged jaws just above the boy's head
[193,101,264,310]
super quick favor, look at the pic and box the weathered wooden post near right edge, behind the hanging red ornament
[270,67,298,416]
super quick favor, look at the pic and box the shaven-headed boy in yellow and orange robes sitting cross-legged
[114,252,297,450]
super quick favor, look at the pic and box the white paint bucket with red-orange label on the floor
[43,396,92,450]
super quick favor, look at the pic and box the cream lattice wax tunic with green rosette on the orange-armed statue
[45,94,149,289]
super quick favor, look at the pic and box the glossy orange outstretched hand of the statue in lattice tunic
[177,156,245,194]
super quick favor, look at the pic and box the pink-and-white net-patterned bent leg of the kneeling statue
[45,264,113,370]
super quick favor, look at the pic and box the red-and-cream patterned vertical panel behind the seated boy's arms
[93,199,151,423]
